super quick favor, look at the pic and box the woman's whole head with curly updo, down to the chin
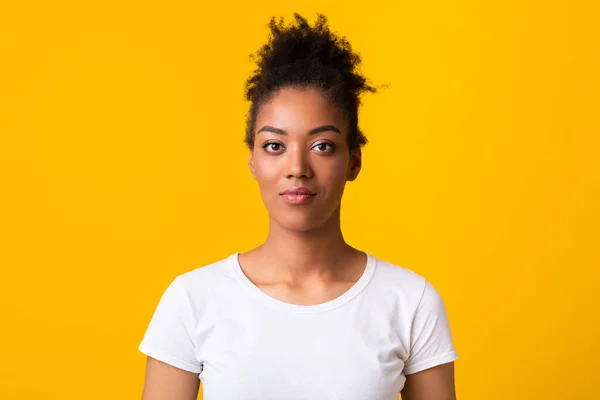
[245,14,375,231]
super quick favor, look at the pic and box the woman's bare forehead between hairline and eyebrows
[256,88,345,130]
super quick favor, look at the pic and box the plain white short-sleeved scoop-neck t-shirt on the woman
[139,253,458,400]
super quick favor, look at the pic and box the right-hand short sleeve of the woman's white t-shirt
[404,281,458,375]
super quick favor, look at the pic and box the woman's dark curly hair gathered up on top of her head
[245,13,376,149]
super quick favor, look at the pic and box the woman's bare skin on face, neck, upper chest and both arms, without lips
[142,87,456,400]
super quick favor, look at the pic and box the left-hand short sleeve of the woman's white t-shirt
[138,277,202,373]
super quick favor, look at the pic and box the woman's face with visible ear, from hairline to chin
[248,88,361,231]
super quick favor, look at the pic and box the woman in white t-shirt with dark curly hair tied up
[139,14,458,400]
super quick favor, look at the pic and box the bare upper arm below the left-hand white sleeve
[142,357,200,400]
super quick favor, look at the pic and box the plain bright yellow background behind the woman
[0,0,600,400]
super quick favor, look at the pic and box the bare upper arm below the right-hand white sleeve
[401,362,456,400]
